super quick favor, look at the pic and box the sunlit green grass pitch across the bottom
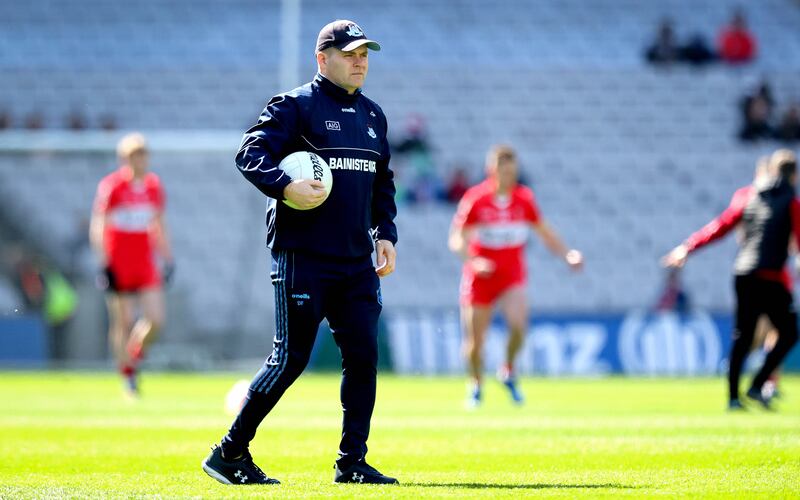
[0,372,800,499]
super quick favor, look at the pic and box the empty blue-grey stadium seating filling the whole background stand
[0,0,800,344]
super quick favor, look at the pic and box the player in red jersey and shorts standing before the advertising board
[448,145,583,407]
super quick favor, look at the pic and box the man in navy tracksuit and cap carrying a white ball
[203,21,397,484]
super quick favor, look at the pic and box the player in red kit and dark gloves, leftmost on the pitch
[89,134,174,396]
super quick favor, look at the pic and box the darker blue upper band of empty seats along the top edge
[0,0,800,70]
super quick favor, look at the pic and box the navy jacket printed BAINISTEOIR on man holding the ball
[236,74,397,257]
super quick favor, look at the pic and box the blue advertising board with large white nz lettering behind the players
[385,310,760,376]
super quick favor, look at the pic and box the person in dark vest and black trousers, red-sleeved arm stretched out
[662,150,800,410]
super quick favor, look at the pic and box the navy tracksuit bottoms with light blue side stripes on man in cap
[222,250,382,464]
